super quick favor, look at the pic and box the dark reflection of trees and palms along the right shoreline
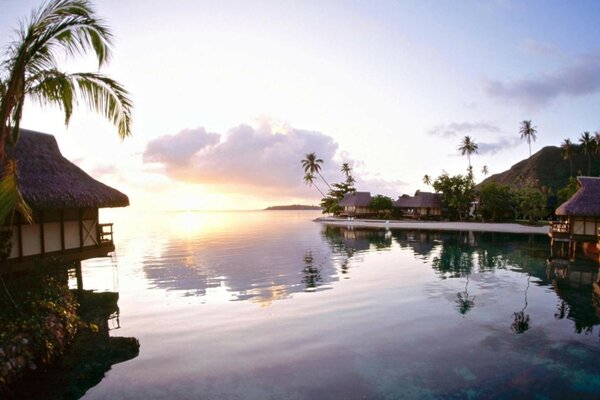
[322,226,600,334]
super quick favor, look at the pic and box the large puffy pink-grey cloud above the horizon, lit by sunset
[142,122,342,195]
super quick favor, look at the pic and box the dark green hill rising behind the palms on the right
[478,146,600,193]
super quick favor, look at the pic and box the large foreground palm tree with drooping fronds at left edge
[0,0,133,222]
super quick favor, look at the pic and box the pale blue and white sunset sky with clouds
[0,0,600,210]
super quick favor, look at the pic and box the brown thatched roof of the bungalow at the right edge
[556,176,600,217]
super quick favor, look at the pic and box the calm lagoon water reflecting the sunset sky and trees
[77,210,600,399]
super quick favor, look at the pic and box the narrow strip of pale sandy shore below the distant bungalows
[315,217,549,235]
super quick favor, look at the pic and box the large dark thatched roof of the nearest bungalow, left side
[7,129,129,210]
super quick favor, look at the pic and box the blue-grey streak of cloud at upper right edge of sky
[485,56,600,108]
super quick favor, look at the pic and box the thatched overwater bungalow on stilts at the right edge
[549,176,600,260]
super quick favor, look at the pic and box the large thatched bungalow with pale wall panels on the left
[2,129,129,271]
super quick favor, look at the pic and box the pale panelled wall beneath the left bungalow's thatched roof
[9,208,100,259]
